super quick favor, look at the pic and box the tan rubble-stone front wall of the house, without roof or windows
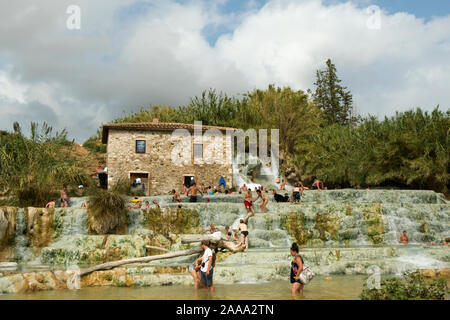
[107,129,233,195]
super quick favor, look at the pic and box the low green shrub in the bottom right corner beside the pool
[360,271,448,300]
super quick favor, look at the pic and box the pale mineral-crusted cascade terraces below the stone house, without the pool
[0,189,450,281]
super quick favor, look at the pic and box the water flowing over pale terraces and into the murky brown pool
[0,188,450,299]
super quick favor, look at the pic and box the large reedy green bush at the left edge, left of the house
[0,123,90,207]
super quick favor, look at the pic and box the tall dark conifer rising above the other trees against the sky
[312,59,358,125]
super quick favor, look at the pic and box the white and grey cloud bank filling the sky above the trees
[0,0,450,141]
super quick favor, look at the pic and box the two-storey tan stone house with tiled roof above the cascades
[102,119,236,195]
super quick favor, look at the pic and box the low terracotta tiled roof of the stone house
[102,122,236,143]
